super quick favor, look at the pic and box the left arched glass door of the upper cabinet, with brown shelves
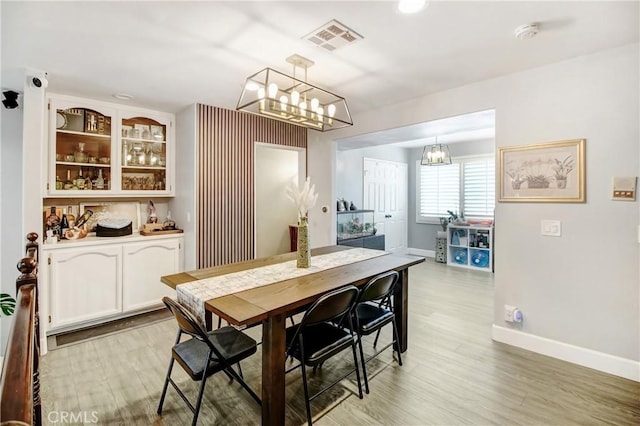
[48,104,114,196]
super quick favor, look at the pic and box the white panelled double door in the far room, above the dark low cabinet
[363,158,408,252]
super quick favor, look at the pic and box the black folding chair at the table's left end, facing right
[157,297,261,425]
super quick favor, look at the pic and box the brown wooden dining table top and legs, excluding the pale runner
[161,246,424,425]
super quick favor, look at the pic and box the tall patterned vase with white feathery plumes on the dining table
[286,177,318,268]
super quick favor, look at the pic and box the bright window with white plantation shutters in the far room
[416,156,496,223]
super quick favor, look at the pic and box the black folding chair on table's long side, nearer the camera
[286,286,363,426]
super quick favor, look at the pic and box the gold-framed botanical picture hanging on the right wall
[497,139,586,203]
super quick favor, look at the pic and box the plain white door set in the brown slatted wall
[254,142,306,257]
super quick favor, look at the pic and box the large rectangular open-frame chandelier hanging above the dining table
[236,55,353,132]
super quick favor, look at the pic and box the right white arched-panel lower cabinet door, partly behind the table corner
[122,240,182,312]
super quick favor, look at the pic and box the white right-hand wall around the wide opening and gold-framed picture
[309,44,640,380]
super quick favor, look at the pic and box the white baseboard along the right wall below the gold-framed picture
[491,324,640,382]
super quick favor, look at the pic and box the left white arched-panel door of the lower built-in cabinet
[49,246,122,328]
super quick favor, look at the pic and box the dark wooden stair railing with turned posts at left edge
[0,232,42,426]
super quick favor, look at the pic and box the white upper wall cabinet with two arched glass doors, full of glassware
[44,95,175,198]
